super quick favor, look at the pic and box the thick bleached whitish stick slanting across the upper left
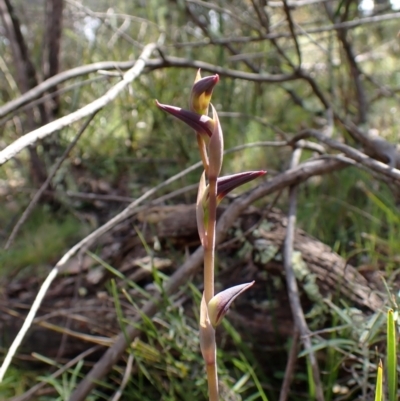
[0,43,157,165]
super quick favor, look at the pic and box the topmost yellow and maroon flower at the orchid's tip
[189,69,219,115]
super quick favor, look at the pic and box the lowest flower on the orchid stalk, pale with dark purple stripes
[208,281,254,327]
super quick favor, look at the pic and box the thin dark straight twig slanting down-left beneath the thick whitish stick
[4,111,97,249]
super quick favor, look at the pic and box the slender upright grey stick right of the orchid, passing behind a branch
[283,148,324,401]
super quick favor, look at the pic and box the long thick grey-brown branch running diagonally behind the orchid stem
[69,159,346,401]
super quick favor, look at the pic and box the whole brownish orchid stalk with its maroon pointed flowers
[156,70,266,401]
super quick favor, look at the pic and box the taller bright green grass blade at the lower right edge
[386,309,397,401]
